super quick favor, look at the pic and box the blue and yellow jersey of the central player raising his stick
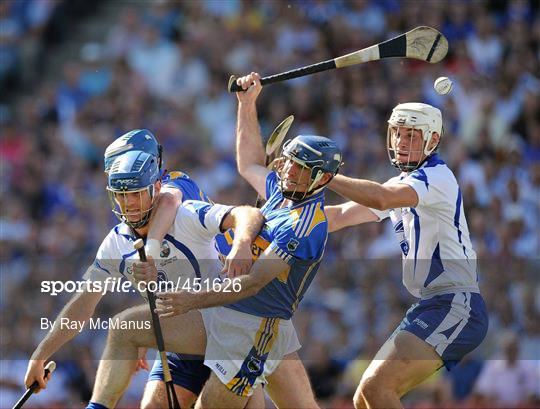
[218,172,328,319]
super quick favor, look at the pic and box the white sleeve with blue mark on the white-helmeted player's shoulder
[398,168,448,206]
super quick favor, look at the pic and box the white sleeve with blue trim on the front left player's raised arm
[177,200,234,239]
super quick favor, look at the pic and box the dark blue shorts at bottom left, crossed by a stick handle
[148,352,210,395]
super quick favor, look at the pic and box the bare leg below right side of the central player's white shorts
[266,352,319,409]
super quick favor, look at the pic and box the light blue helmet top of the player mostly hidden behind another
[103,129,163,173]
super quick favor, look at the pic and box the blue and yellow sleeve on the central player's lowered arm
[270,203,328,265]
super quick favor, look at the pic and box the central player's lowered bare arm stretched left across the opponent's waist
[156,248,290,317]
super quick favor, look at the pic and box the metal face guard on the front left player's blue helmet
[107,185,155,229]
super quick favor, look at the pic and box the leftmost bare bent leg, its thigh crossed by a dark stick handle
[92,305,206,407]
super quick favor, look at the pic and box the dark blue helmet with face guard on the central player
[279,135,342,201]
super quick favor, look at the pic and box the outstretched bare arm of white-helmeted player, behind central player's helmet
[329,175,418,210]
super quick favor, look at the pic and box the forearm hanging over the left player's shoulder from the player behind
[145,186,183,259]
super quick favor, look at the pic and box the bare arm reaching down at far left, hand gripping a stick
[24,291,103,390]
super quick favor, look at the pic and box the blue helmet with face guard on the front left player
[107,151,160,229]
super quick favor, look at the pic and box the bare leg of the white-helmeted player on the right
[354,331,443,409]
